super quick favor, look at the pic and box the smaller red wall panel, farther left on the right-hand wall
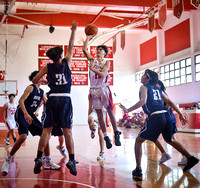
[140,37,157,65]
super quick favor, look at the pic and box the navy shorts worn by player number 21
[139,113,172,142]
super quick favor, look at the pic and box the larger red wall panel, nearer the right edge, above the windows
[165,19,190,56]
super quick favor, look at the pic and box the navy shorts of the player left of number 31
[15,109,42,136]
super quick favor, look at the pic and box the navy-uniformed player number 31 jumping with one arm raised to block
[33,21,77,176]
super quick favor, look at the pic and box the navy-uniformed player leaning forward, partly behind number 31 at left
[1,71,60,174]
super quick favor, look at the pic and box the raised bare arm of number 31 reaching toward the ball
[65,21,77,66]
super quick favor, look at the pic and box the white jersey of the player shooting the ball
[89,59,109,87]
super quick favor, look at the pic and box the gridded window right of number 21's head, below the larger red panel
[160,56,192,87]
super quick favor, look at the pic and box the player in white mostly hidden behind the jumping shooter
[88,94,107,161]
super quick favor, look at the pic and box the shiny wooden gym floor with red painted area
[0,126,200,188]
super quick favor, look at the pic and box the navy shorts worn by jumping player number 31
[44,96,73,129]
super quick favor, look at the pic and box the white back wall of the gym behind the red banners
[0,25,139,125]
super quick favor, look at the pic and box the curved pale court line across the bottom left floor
[0,178,95,188]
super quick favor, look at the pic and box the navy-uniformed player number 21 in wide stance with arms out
[120,69,199,176]
